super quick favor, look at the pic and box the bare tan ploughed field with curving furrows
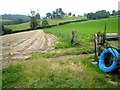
[0,30,57,59]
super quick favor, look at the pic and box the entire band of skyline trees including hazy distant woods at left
[2,8,120,32]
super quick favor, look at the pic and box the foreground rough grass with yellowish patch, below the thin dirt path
[2,56,119,88]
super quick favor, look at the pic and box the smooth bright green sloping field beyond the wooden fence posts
[45,17,118,34]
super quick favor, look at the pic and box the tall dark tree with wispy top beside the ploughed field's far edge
[29,11,40,29]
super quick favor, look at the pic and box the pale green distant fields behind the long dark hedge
[5,17,86,31]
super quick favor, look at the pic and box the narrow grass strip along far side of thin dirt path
[32,46,94,59]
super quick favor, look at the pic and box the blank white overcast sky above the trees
[0,0,120,16]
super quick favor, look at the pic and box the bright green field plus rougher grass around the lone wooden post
[45,17,118,48]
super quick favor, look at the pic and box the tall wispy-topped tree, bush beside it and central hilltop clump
[29,8,70,29]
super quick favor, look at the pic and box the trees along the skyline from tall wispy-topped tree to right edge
[29,8,120,29]
